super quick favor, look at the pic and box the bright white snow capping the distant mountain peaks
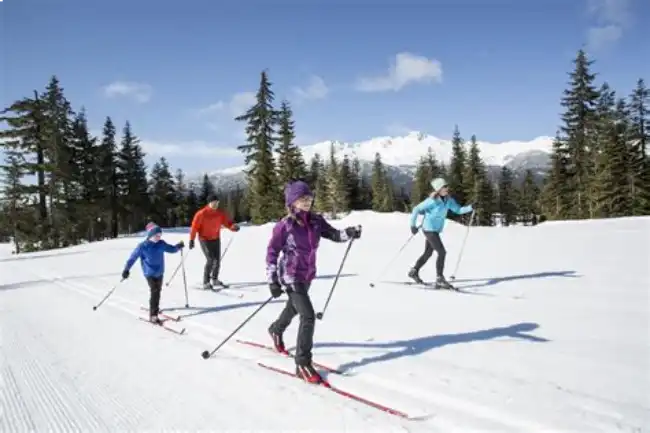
[211,131,553,176]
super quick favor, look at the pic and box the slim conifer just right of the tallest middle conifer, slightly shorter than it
[277,101,307,186]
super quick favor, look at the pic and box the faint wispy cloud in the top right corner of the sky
[586,0,632,52]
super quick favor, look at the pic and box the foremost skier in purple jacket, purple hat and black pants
[266,181,361,383]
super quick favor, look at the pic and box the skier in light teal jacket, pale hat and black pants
[408,178,474,289]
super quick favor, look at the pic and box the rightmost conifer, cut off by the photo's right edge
[629,79,650,215]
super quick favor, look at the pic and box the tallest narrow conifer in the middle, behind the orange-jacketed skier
[235,71,283,224]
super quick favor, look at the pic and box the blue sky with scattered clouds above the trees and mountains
[0,0,650,176]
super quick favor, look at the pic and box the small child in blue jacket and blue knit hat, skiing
[122,223,185,324]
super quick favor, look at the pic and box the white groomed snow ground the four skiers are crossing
[0,212,650,432]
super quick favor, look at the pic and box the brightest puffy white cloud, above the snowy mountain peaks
[356,52,442,92]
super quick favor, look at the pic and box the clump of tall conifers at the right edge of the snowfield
[541,51,650,219]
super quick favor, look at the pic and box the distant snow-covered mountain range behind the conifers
[197,131,553,191]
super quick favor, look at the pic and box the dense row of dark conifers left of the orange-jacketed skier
[0,76,229,253]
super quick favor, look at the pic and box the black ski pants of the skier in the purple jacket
[269,283,316,365]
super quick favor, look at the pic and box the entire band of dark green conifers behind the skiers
[0,51,650,253]
